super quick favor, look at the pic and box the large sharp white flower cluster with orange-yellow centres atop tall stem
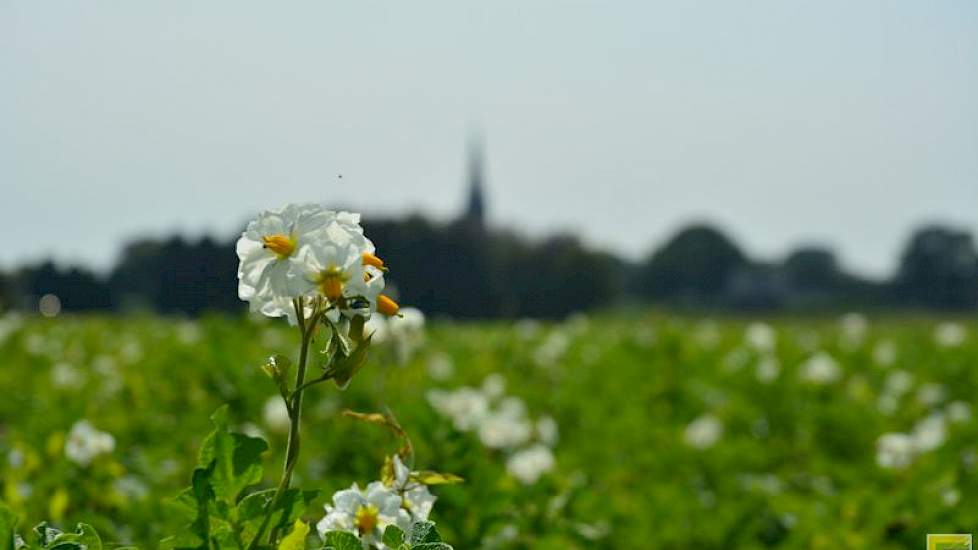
[237,204,398,324]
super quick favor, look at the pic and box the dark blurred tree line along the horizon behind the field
[0,216,978,318]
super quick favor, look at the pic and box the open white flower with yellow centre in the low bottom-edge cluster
[316,481,406,548]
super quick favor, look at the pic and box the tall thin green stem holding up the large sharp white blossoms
[248,298,316,550]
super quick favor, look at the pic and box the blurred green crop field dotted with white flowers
[0,313,978,549]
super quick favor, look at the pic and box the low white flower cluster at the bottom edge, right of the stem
[316,455,436,549]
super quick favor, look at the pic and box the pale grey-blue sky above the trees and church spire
[0,0,978,275]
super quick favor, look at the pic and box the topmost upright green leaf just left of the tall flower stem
[198,405,268,505]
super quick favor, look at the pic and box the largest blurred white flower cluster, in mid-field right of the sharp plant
[426,374,558,485]
